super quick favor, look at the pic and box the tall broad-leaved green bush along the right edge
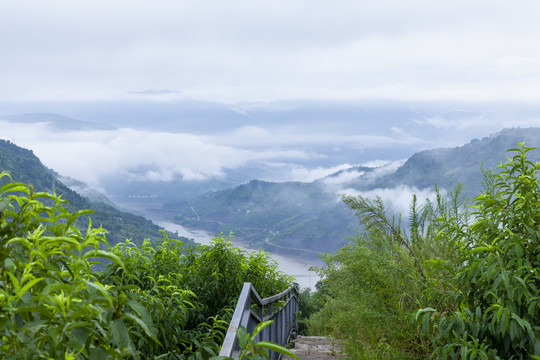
[415,144,540,359]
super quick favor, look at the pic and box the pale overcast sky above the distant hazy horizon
[0,0,540,102]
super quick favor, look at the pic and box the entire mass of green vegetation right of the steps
[309,146,540,359]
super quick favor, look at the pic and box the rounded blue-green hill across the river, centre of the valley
[165,180,357,255]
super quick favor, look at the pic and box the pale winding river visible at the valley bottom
[154,221,319,289]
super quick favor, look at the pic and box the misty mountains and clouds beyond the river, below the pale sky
[0,101,540,259]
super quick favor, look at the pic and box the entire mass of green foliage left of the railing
[0,172,292,359]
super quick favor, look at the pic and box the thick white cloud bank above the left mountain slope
[0,121,308,187]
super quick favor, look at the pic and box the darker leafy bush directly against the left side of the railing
[100,233,292,359]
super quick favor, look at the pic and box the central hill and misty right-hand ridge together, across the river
[164,128,540,256]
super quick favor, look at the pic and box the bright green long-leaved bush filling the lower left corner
[0,172,157,359]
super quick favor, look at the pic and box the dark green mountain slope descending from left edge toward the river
[0,140,171,245]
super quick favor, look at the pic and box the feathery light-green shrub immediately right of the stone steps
[309,187,461,359]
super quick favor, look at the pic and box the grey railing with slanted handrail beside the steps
[219,283,298,360]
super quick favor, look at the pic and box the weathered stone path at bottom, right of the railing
[283,335,344,360]
